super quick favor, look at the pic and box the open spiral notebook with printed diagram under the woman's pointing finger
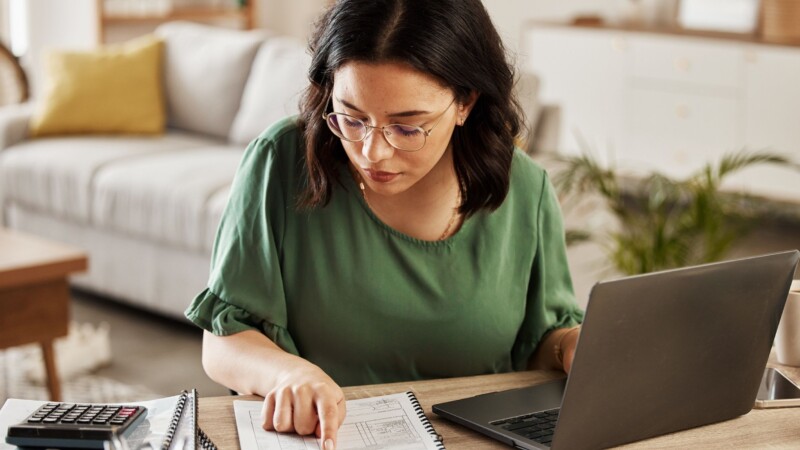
[233,391,445,450]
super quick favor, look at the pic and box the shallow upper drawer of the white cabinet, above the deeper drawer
[630,36,744,89]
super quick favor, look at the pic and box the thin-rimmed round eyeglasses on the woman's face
[322,98,456,152]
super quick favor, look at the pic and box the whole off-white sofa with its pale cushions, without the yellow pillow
[0,22,310,318]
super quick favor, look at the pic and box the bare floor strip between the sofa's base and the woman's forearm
[71,290,228,397]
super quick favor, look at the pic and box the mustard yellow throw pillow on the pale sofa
[31,36,166,136]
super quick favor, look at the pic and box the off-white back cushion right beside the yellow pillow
[156,22,265,138]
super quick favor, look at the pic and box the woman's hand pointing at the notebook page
[262,361,346,450]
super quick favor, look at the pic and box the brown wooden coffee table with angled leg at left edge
[0,228,88,401]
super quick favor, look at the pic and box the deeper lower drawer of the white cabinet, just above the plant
[620,88,741,177]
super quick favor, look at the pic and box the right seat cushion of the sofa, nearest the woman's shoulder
[92,145,244,251]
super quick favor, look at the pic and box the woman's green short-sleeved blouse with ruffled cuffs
[186,118,583,386]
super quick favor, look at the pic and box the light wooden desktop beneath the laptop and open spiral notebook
[200,362,800,450]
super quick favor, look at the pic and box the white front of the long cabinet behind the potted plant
[524,25,800,203]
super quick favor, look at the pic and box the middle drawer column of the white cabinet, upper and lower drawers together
[619,35,742,177]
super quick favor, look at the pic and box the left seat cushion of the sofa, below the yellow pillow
[0,132,218,223]
